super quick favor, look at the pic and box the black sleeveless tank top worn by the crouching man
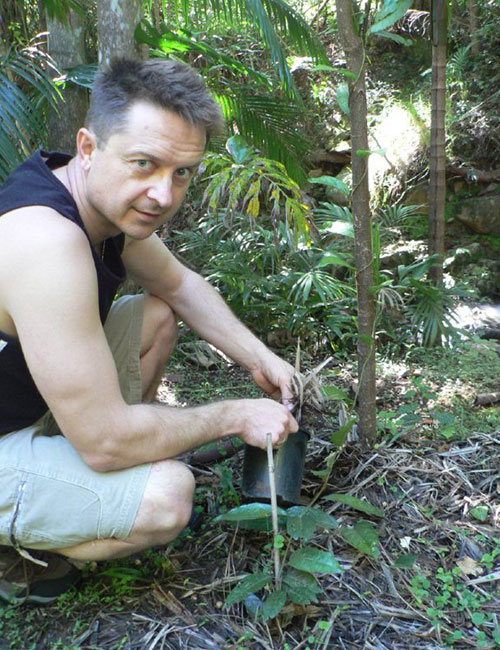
[0,151,125,435]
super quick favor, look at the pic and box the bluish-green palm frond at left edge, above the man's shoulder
[0,41,60,180]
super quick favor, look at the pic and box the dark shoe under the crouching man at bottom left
[0,548,81,605]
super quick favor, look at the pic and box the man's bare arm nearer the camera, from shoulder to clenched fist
[0,208,296,471]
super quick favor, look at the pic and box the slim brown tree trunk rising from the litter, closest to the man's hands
[336,0,376,444]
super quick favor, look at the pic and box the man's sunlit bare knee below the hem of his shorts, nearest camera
[131,460,195,546]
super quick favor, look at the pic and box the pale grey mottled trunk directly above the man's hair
[97,0,145,64]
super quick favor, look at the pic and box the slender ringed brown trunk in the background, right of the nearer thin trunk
[429,0,448,286]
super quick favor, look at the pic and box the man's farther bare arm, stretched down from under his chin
[124,236,294,403]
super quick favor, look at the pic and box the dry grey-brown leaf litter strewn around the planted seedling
[15,362,500,650]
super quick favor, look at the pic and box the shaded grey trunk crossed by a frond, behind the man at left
[47,11,88,154]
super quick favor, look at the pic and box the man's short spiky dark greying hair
[85,58,224,146]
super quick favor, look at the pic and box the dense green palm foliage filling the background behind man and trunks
[0,0,499,350]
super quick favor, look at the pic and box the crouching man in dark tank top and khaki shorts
[0,60,297,602]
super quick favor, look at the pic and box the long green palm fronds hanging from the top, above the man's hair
[136,0,327,183]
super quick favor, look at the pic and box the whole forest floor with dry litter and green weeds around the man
[0,339,500,650]
